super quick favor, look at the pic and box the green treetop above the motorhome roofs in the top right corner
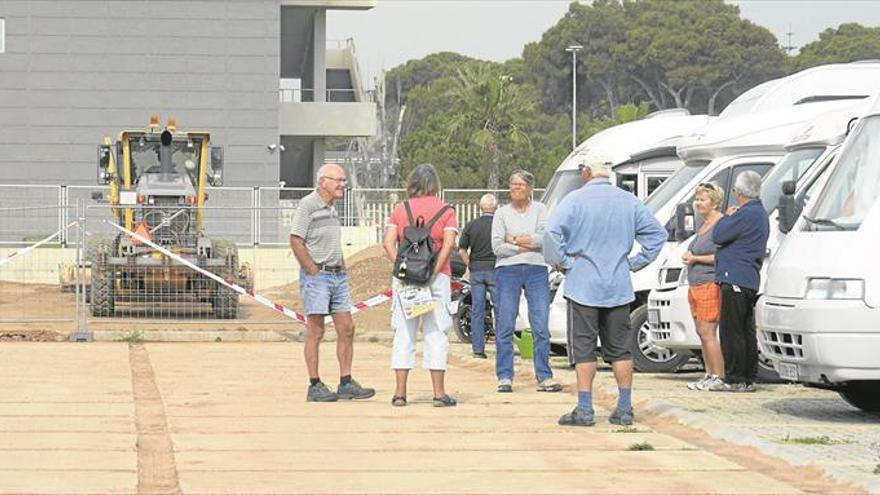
[792,23,880,71]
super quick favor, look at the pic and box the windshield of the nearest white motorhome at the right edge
[804,115,880,230]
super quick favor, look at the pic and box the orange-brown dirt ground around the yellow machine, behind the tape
[0,246,391,341]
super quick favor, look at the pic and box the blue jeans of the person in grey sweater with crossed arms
[495,264,553,382]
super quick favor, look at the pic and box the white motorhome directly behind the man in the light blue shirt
[517,61,880,372]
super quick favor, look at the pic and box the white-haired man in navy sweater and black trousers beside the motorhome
[712,170,770,392]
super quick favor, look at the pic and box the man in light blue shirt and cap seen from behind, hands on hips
[544,151,667,426]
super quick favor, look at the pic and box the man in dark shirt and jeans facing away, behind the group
[458,194,498,359]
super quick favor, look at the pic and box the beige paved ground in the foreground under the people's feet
[0,343,852,494]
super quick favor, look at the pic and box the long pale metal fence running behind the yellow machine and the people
[0,185,541,246]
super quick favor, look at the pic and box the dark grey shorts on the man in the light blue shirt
[567,299,633,365]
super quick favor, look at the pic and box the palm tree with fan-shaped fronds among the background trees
[448,69,532,189]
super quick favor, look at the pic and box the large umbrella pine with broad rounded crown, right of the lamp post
[623,0,785,114]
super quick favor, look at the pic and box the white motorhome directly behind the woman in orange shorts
[648,100,866,380]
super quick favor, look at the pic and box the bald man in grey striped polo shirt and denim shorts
[290,164,376,402]
